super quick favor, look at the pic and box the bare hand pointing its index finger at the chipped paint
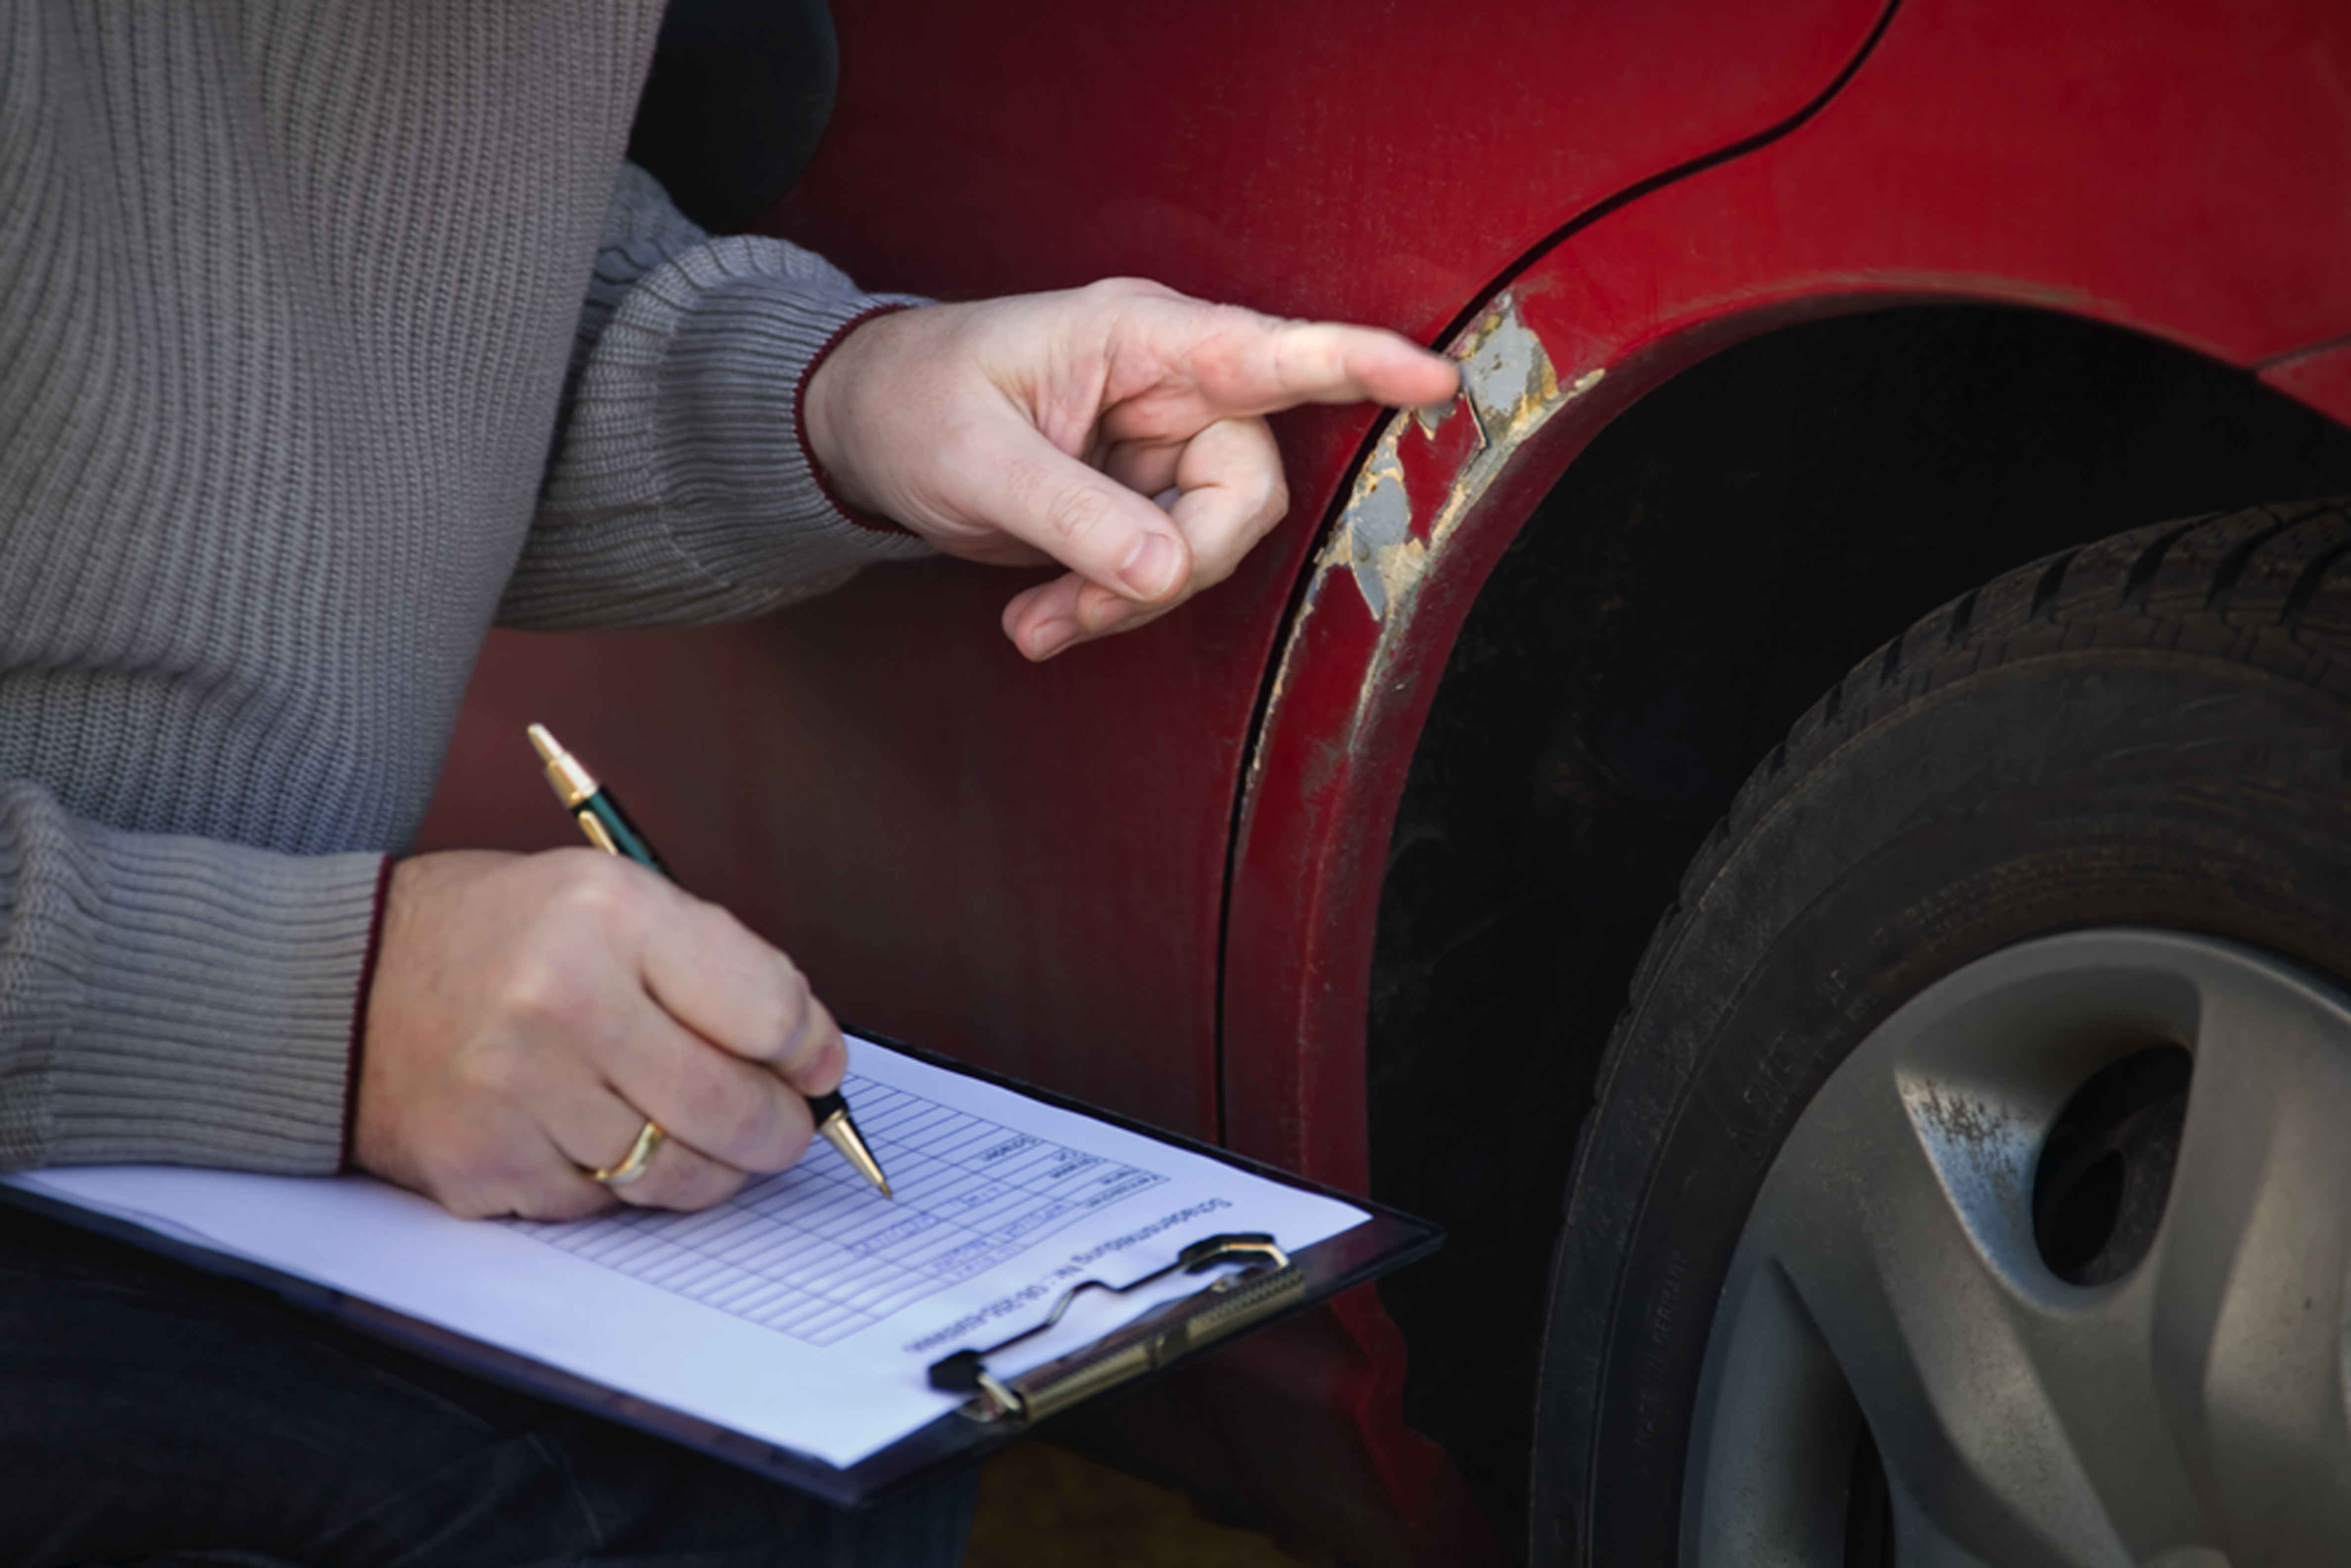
[804,280,1460,658]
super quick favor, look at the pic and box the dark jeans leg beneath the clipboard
[0,1206,974,1568]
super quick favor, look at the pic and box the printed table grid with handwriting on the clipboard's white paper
[508,1075,1166,1345]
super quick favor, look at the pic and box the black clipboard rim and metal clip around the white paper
[0,1029,1441,1507]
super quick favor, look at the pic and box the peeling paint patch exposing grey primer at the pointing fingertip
[1317,289,1606,621]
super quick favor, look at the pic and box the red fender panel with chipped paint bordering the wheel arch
[1220,0,2351,1182]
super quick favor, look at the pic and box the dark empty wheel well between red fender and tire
[1369,305,2351,1530]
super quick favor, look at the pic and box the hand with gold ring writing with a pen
[355,849,849,1220]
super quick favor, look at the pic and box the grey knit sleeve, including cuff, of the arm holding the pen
[0,783,388,1176]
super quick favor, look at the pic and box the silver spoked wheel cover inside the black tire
[1695,931,2351,1568]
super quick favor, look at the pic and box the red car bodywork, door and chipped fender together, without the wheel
[426,0,2351,1564]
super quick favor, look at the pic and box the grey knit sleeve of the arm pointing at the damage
[498,167,929,630]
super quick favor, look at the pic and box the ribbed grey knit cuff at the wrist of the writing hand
[30,828,383,1173]
